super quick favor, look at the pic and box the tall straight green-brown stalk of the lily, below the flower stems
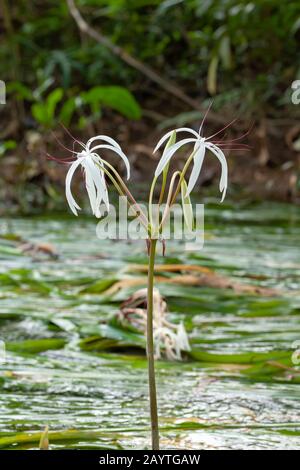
[147,239,159,450]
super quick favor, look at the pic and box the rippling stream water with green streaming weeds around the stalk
[0,204,300,449]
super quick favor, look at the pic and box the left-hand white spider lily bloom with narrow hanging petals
[66,135,130,217]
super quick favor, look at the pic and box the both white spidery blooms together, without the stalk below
[55,121,234,218]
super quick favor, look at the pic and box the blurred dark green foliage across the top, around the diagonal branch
[0,0,300,127]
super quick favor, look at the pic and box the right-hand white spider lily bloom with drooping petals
[153,127,228,202]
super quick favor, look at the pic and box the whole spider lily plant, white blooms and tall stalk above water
[49,116,236,450]
